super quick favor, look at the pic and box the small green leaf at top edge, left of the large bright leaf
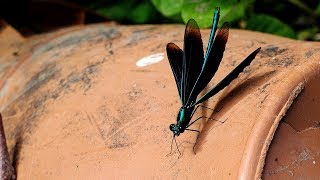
[151,0,183,17]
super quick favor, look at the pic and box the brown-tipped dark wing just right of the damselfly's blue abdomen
[187,23,229,104]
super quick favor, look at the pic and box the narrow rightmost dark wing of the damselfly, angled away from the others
[192,47,261,106]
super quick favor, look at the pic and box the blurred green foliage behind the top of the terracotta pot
[83,0,320,41]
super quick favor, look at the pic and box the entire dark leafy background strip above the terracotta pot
[0,0,320,41]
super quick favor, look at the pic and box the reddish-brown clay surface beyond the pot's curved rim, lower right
[263,70,320,179]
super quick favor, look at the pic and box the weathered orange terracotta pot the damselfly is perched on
[0,20,320,179]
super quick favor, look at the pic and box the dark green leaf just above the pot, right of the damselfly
[246,14,296,38]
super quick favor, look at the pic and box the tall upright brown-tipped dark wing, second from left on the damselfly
[181,19,203,105]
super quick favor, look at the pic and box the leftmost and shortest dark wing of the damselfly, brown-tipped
[167,43,183,101]
